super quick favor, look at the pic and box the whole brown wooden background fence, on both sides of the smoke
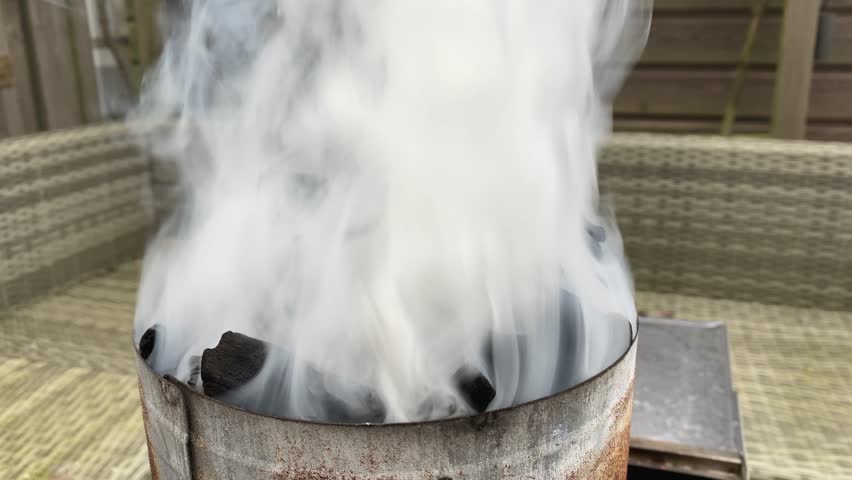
[0,0,852,141]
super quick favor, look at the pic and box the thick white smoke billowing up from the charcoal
[131,0,649,421]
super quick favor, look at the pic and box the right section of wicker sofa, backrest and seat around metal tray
[600,135,852,479]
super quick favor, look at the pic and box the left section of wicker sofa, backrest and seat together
[0,125,152,480]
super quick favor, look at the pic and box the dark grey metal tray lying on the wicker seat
[630,318,747,480]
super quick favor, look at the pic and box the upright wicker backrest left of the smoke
[0,124,151,309]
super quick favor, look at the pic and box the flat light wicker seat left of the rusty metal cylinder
[0,263,150,480]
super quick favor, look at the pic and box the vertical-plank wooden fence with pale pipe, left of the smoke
[0,0,152,138]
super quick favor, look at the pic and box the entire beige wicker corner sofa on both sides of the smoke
[0,125,852,479]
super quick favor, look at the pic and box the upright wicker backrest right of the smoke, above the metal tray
[600,134,852,311]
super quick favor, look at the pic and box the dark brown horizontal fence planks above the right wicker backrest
[614,0,852,141]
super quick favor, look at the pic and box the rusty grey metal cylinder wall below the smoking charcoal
[137,339,636,480]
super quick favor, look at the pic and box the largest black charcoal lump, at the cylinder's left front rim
[201,332,268,397]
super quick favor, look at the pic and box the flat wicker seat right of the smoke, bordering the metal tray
[637,293,852,480]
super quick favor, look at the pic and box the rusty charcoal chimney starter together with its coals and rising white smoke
[129,0,651,480]
